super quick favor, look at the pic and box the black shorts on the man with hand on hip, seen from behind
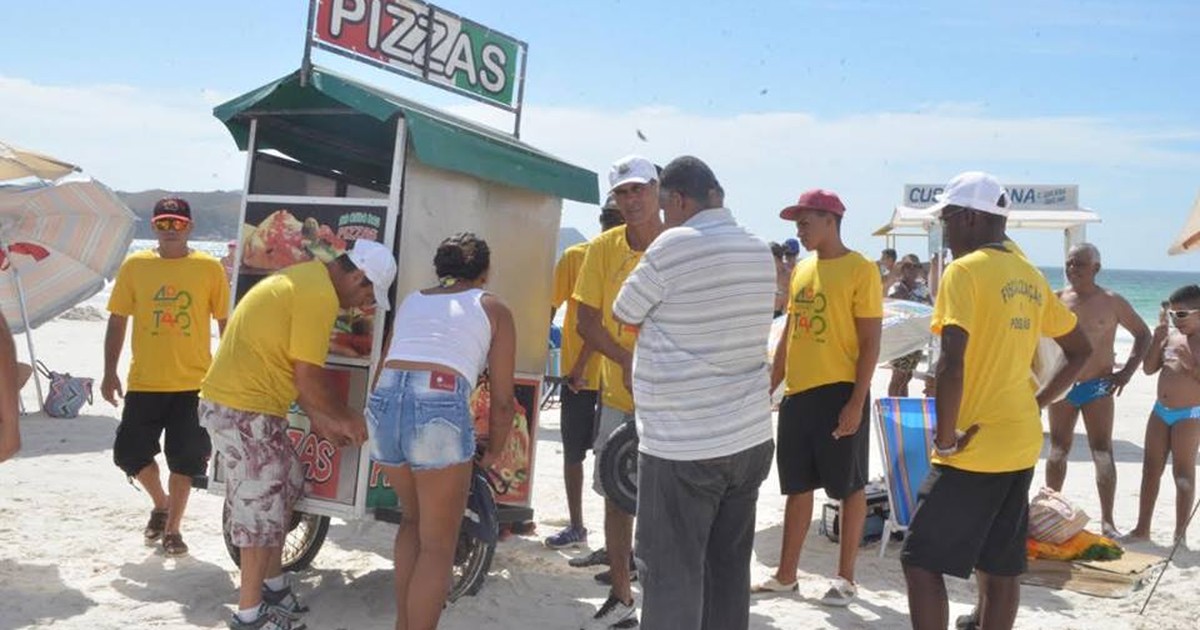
[900,464,1033,578]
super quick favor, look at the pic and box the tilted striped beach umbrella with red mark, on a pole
[0,178,136,402]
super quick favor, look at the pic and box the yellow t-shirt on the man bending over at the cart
[200,260,337,418]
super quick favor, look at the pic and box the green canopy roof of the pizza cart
[212,67,600,204]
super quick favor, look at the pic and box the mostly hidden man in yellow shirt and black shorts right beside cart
[545,194,625,550]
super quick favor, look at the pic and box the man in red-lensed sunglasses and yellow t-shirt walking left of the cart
[100,197,229,556]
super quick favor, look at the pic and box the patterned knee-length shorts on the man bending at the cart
[199,400,304,547]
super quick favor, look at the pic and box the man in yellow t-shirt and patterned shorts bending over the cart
[199,240,396,630]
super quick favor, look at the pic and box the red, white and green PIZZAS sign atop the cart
[310,0,526,112]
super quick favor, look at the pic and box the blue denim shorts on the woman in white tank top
[366,367,475,470]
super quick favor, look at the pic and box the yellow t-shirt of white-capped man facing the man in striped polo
[572,226,642,413]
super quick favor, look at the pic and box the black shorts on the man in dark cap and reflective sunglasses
[113,391,212,476]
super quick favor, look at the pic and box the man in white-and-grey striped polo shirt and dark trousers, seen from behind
[613,156,775,630]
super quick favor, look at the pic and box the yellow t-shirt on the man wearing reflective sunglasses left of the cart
[108,250,229,391]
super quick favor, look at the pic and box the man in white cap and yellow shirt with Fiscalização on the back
[901,172,1091,630]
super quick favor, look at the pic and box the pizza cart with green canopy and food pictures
[209,0,599,597]
